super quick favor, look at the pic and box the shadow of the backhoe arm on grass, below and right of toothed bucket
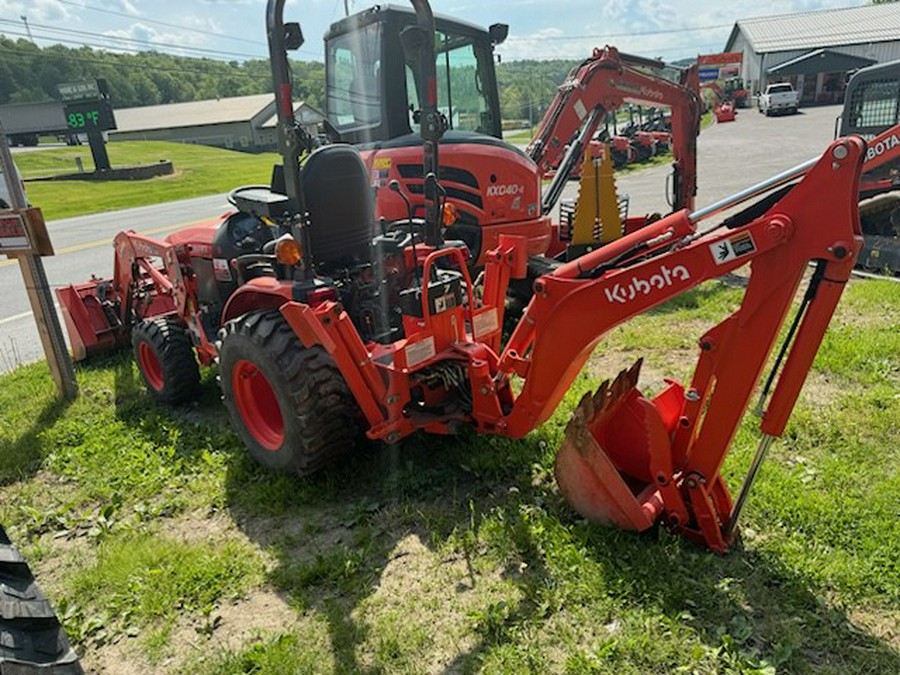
[574,522,900,674]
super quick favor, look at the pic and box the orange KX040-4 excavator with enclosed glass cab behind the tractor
[325,5,700,266]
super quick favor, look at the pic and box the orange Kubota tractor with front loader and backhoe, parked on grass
[61,0,865,552]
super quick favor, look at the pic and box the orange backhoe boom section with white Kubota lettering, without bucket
[501,138,863,435]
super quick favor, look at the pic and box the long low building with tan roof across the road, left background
[109,94,324,152]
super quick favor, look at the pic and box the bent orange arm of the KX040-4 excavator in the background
[527,46,700,213]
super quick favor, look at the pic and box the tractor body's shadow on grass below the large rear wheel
[219,435,546,673]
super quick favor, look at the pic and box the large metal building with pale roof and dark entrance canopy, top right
[724,3,900,105]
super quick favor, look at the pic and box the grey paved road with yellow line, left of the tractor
[0,195,230,372]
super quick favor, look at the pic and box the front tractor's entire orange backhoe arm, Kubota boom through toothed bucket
[499,137,865,551]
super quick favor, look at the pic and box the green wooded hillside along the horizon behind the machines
[0,36,573,123]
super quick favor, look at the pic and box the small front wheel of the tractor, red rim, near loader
[131,316,200,405]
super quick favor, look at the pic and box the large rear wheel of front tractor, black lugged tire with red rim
[219,311,360,475]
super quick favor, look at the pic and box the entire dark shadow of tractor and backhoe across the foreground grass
[218,420,900,673]
